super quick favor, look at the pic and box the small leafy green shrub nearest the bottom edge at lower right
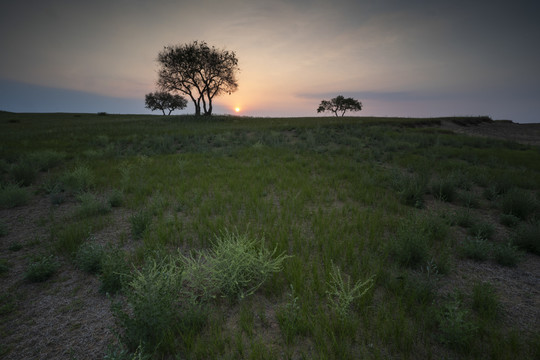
[437,296,477,350]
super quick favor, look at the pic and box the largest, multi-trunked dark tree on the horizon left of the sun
[158,41,239,115]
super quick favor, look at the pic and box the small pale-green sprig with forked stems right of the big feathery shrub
[326,264,375,320]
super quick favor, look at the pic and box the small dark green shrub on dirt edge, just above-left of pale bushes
[99,248,130,294]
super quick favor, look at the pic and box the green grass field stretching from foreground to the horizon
[0,113,540,359]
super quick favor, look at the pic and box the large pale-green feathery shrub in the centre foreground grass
[182,231,288,300]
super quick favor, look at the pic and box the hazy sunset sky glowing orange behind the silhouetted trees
[0,0,540,123]
